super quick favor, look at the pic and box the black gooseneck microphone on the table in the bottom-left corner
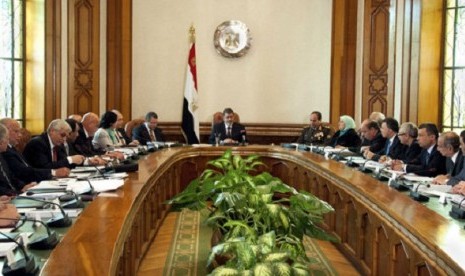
[0,232,39,276]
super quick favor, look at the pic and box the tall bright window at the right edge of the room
[442,0,465,131]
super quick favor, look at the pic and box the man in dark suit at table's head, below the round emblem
[209,107,246,145]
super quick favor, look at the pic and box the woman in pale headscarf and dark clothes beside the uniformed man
[328,115,361,147]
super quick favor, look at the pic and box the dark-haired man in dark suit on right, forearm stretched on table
[393,123,446,177]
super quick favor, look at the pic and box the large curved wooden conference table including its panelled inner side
[37,145,465,275]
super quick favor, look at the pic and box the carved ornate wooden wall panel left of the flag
[68,0,100,114]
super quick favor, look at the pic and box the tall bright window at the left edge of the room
[0,0,25,120]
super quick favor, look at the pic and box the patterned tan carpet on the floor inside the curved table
[163,209,337,276]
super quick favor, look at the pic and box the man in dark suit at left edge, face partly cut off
[0,124,37,196]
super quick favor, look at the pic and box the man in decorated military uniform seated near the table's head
[297,111,333,145]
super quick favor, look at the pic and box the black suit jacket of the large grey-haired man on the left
[23,132,74,169]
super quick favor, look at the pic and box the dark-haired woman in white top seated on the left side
[92,111,121,150]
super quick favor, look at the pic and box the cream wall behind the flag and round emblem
[132,0,332,123]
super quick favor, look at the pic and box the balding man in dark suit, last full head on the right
[433,131,463,184]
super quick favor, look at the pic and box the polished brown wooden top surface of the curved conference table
[35,146,465,275]
